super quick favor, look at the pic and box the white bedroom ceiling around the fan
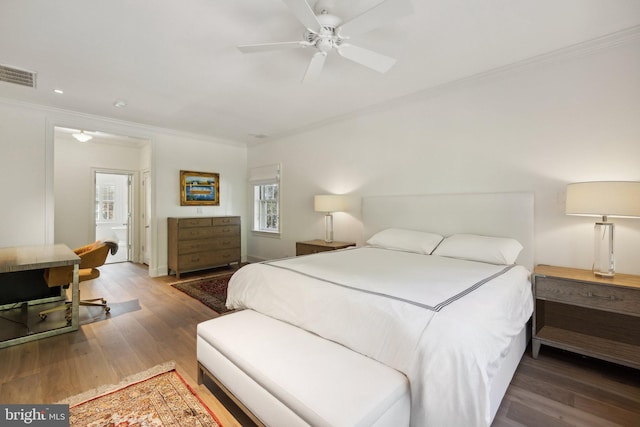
[0,0,640,143]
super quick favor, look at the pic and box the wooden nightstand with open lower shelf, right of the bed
[532,265,640,369]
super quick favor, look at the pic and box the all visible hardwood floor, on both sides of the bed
[0,263,640,427]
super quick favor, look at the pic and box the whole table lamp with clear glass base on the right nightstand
[565,181,640,277]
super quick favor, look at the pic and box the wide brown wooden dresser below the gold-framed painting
[168,216,240,278]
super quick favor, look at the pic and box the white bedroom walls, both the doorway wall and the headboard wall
[0,39,640,275]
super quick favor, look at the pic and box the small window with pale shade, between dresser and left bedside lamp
[249,165,280,234]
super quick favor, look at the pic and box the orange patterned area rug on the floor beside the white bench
[59,364,222,427]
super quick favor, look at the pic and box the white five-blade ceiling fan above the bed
[238,0,413,82]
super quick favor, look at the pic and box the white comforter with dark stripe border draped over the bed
[227,247,533,427]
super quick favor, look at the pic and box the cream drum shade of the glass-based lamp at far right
[565,181,640,218]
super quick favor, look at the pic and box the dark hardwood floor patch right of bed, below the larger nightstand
[493,346,640,427]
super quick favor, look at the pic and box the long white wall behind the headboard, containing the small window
[248,38,640,274]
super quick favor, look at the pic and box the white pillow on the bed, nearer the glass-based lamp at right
[433,234,523,265]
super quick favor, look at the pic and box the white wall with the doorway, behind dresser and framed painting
[0,99,247,276]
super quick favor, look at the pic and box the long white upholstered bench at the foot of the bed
[197,310,410,427]
